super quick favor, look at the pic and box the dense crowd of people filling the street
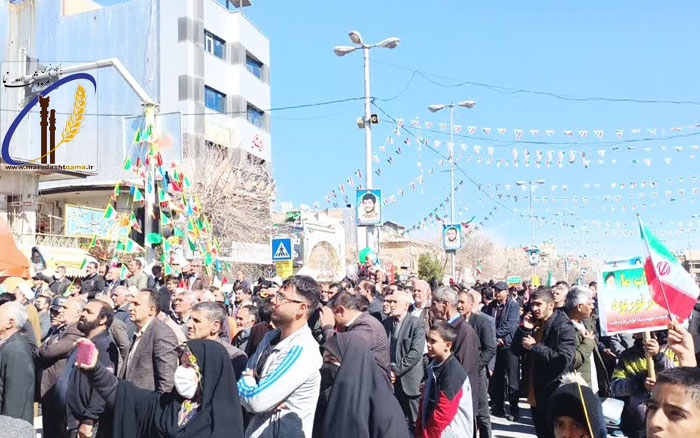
[0,259,700,438]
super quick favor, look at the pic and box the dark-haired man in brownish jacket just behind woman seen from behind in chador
[321,291,390,383]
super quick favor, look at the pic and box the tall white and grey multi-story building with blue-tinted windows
[0,0,271,250]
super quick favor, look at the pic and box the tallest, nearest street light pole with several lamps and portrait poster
[333,30,400,253]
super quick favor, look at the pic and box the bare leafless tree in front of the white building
[183,136,275,247]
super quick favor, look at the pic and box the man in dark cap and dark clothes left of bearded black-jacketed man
[484,281,520,421]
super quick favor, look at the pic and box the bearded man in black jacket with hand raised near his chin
[511,289,576,438]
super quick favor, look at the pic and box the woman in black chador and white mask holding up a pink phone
[76,339,243,438]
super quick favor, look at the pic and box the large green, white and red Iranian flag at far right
[637,216,700,319]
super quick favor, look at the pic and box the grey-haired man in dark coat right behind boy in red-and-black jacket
[430,287,481,418]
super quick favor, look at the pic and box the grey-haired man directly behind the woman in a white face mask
[187,302,248,380]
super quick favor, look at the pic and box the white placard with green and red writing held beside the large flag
[598,263,669,336]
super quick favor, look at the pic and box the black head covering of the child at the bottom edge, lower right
[548,376,607,438]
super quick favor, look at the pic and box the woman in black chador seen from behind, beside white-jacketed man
[313,333,410,438]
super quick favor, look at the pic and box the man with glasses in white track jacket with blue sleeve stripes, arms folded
[238,275,323,438]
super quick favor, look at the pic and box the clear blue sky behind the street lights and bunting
[245,0,700,256]
